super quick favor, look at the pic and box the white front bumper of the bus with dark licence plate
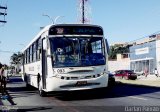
[46,75,108,92]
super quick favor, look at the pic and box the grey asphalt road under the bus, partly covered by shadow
[2,77,160,112]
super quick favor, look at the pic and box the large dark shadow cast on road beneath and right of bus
[50,84,160,101]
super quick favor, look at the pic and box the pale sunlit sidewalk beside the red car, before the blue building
[116,75,160,87]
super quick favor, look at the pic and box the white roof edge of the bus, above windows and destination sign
[22,23,102,52]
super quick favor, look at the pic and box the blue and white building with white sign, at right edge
[130,34,160,74]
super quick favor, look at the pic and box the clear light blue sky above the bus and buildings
[0,0,160,64]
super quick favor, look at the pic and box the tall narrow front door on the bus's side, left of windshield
[41,39,47,89]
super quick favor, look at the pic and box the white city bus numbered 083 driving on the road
[22,24,108,96]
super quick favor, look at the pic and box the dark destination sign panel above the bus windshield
[49,26,103,35]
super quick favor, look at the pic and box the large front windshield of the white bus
[50,37,106,67]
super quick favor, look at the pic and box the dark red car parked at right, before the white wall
[114,70,137,80]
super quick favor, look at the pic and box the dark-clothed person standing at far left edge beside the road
[0,63,6,95]
